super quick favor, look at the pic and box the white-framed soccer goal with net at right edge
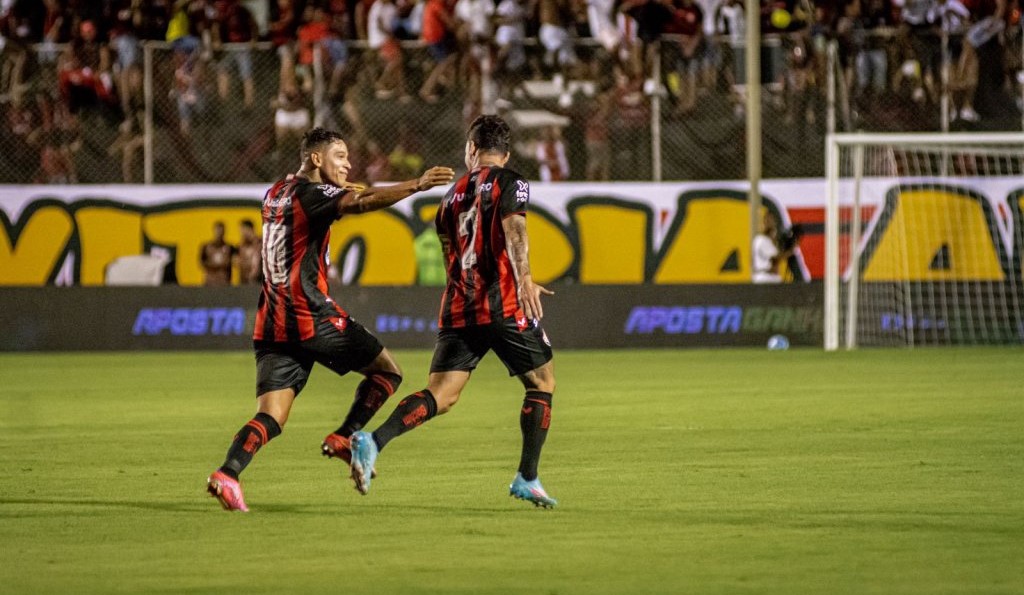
[824,133,1024,350]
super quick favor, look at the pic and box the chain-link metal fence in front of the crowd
[0,28,1022,183]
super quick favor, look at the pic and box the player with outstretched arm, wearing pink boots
[207,128,455,511]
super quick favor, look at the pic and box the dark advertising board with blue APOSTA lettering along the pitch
[0,283,823,351]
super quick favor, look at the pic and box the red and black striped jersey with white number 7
[434,167,529,329]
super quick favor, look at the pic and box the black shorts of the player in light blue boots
[430,317,552,376]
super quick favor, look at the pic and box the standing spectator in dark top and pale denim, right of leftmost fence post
[213,0,259,108]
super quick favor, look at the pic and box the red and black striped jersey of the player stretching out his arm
[253,178,348,341]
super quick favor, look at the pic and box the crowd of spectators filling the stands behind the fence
[0,0,1021,183]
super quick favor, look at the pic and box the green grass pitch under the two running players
[0,348,1024,595]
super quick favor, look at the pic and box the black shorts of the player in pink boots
[253,318,384,396]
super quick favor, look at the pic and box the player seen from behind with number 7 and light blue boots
[351,116,557,507]
